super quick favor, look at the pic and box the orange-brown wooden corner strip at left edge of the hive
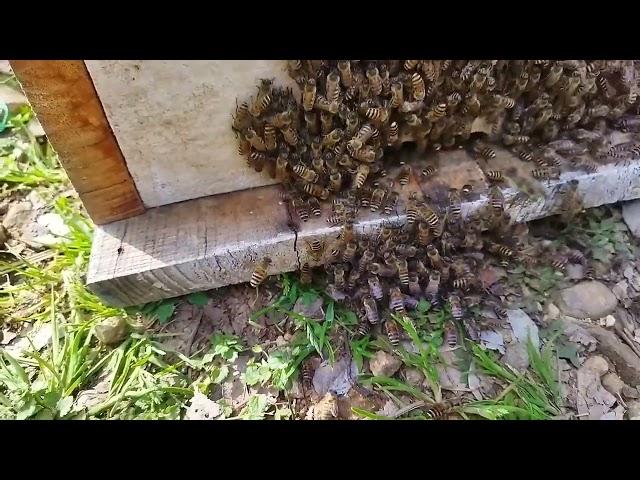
[11,60,144,224]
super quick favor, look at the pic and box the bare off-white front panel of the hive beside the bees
[86,60,299,207]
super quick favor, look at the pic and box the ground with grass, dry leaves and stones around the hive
[0,63,640,420]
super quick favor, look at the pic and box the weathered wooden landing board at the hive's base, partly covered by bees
[87,150,640,306]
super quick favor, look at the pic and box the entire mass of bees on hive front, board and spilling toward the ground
[233,60,640,346]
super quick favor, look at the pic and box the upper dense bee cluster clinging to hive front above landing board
[233,60,640,203]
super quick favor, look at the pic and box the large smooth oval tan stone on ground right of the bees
[558,280,618,318]
